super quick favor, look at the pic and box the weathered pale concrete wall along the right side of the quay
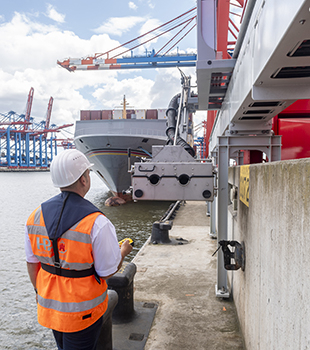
[228,159,310,350]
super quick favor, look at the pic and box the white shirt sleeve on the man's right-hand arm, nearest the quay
[91,215,122,277]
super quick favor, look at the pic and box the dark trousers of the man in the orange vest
[53,317,103,350]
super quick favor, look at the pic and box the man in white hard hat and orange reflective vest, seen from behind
[25,150,132,350]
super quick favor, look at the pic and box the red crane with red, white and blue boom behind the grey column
[57,0,243,154]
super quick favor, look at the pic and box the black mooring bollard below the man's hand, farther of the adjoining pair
[107,263,137,322]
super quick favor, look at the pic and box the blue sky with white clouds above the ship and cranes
[0,0,206,138]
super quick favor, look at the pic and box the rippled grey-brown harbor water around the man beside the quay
[0,172,170,350]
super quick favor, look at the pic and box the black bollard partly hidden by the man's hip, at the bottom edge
[96,290,118,350]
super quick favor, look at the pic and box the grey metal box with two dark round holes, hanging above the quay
[132,145,214,201]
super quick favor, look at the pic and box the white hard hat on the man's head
[50,149,94,188]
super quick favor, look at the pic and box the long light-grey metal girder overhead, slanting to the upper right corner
[209,0,310,151]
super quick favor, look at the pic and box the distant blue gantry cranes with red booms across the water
[0,88,73,170]
